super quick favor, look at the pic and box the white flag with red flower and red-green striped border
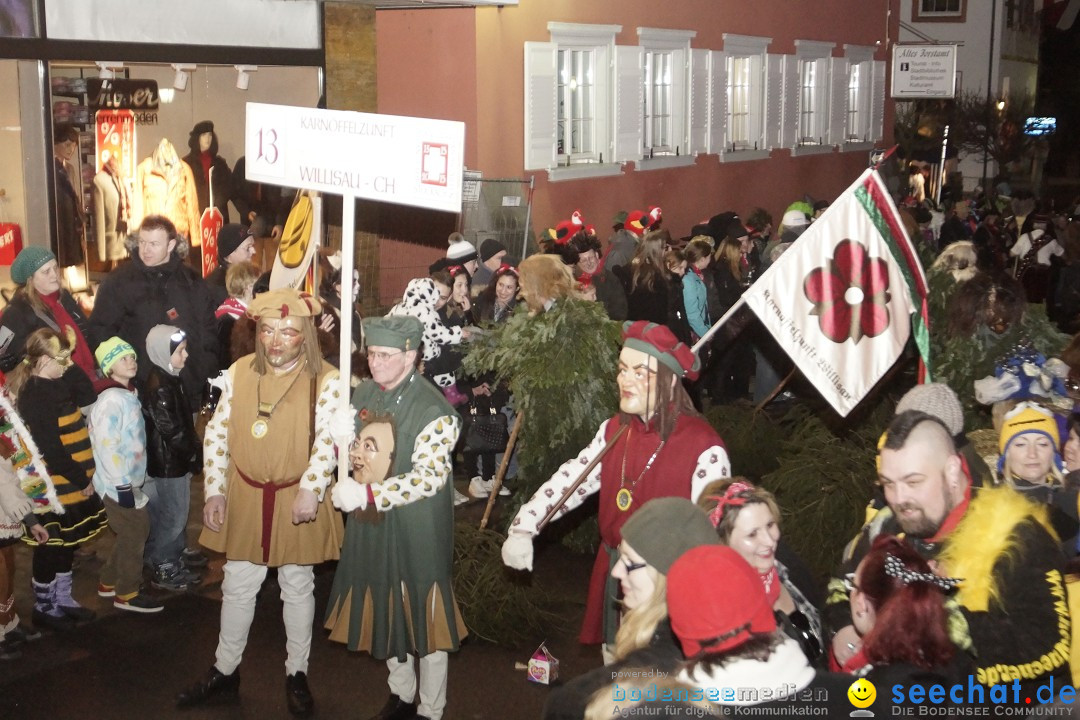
[743,168,930,416]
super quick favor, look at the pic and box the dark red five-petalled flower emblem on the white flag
[802,240,889,343]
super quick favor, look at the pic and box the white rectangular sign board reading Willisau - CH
[244,103,465,213]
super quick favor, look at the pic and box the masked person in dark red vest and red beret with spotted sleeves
[502,321,731,662]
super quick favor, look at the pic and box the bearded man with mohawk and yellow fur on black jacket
[825,410,1071,703]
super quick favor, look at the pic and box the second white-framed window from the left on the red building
[637,27,697,158]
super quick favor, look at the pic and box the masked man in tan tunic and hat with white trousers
[177,289,342,717]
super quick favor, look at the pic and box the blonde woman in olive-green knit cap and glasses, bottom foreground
[543,498,718,720]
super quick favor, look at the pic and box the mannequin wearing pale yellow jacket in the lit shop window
[129,138,200,245]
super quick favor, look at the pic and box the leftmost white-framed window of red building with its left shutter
[525,23,617,179]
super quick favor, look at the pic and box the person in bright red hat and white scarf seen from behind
[585,545,854,720]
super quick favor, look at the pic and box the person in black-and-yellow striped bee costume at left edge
[8,328,107,630]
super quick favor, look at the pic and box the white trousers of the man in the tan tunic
[215,560,315,675]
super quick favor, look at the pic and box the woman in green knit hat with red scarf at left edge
[0,246,98,381]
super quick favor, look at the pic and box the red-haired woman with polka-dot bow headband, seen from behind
[829,534,972,688]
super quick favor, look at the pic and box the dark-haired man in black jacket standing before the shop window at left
[90,215,218,407]
